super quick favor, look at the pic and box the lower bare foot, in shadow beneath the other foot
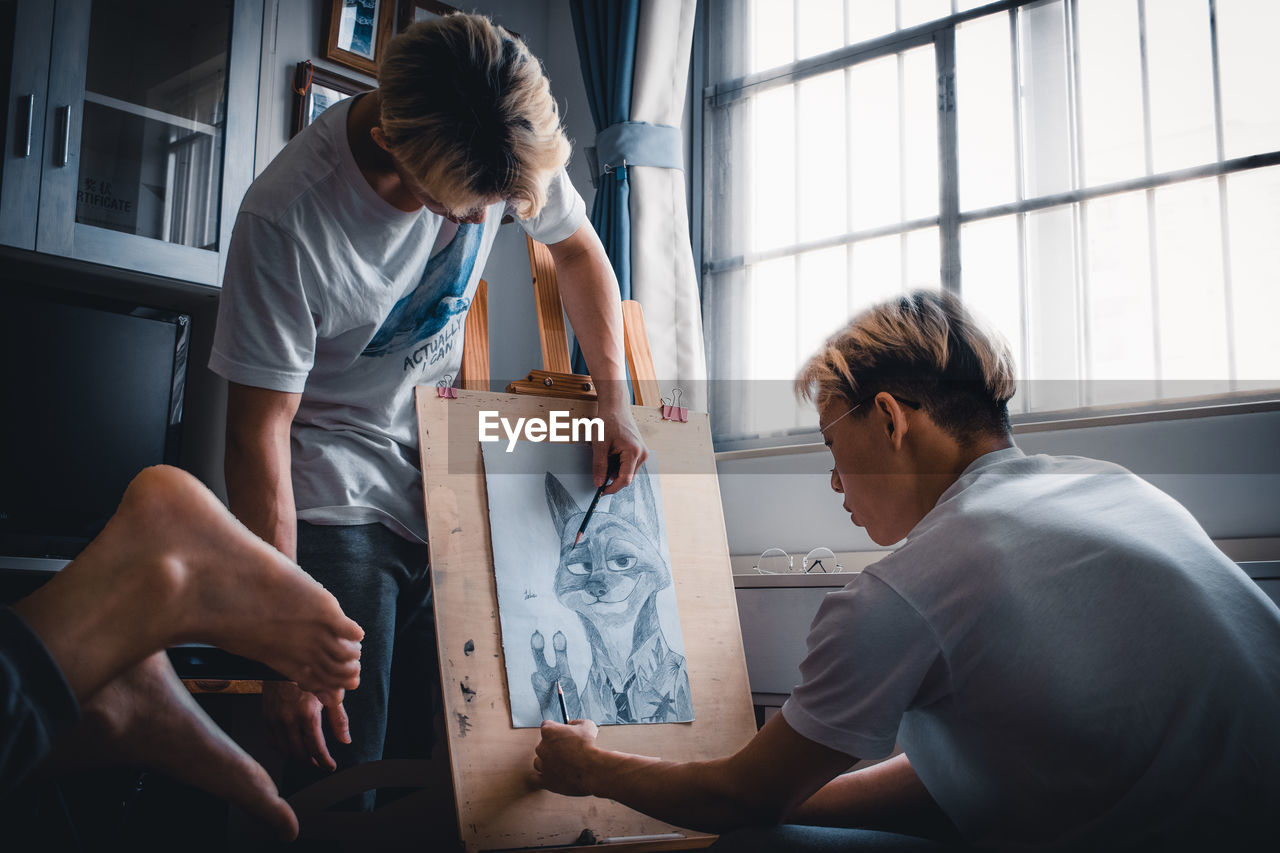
[40,652,298,840]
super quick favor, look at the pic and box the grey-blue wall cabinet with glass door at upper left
[0,0,262,286]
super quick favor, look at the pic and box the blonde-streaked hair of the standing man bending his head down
[378,13,571,219]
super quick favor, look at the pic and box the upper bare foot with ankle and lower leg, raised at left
[14,466,364,706]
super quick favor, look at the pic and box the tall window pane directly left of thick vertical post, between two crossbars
[901,46,938,219]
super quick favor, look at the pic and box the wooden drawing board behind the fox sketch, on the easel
[417,387,755,853]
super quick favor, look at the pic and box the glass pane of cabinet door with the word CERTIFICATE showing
[76,0,232,252]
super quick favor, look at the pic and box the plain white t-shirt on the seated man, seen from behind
[782,447,1280,849]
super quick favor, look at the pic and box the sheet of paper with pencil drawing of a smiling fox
[481,441,694,727]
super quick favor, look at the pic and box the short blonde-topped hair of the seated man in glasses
[796,291,1016,441]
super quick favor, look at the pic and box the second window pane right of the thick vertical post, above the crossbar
[1018,0,1071,197]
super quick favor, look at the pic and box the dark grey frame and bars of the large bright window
[690,0,1280,452]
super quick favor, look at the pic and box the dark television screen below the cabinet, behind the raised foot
[0,286,191,558]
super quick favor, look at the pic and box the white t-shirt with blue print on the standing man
[209,100,586,540]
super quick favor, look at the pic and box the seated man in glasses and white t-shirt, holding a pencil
[534,292,1280,850]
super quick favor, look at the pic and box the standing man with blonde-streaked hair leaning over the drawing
[210,14,646,807]
